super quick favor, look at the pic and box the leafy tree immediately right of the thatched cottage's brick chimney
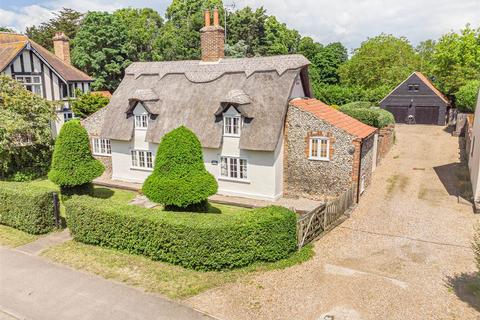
[227,7,268,57]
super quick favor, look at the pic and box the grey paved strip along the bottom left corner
[0,247,214,320]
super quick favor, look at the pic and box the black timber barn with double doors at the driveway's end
[380,72,450,125]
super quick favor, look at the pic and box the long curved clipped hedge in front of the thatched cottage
[65,196,296,270]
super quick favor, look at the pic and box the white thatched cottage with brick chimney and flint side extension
[83,11,376,200]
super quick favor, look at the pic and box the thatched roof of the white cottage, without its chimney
[101,55,309,151]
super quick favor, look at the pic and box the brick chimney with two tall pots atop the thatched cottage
[200,8,225,62]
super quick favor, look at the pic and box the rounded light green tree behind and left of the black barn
[339,34,420,88]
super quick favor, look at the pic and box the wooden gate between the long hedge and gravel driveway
[297,184,356,249]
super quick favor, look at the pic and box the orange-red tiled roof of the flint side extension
[290,99,377,139]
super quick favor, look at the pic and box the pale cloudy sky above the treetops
[0,0,480,49]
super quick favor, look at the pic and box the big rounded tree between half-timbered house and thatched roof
[72,12,131,91]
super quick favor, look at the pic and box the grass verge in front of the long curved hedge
[42,241,314,299]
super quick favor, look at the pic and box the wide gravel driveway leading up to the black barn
[187,125,480,320]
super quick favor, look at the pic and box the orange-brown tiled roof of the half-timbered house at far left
[0,32,92,81]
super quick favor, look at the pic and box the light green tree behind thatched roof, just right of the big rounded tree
[113,8,163,61]
